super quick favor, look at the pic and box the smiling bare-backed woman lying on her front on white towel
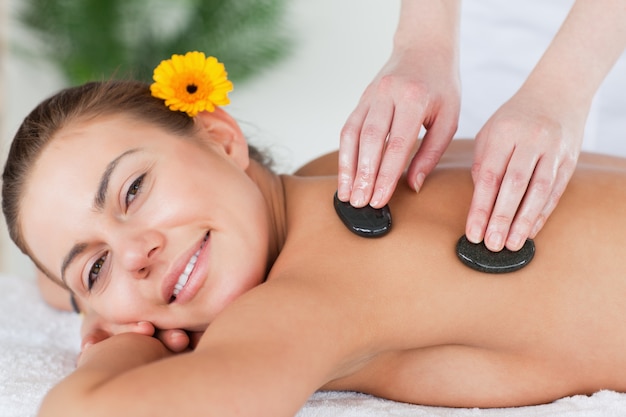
[3,82,626,417]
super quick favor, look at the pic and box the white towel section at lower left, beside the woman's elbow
[0,275,80,417]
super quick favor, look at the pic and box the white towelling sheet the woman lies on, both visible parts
[0,275,626,417]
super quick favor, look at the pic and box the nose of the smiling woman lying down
[118,231,164,278]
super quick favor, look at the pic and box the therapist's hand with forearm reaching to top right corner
[466,0,626,251]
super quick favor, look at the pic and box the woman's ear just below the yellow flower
[194,107,250,169]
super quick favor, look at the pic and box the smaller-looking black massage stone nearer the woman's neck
[333,193,391,237]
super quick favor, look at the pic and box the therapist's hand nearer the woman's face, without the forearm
[338,52,460,207]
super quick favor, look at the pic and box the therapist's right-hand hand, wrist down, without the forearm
[466,93,587,251]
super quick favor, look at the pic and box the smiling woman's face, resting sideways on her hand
[21,116,270,330]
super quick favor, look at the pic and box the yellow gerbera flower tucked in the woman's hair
[150,51,233,117]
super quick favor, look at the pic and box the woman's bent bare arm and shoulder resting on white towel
[40,283,363,417]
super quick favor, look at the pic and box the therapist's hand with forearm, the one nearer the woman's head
[337,0,460,207]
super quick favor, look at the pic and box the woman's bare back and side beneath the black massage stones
[270,142,626,405]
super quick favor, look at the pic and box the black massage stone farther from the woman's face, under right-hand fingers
[456,235,535,274]
